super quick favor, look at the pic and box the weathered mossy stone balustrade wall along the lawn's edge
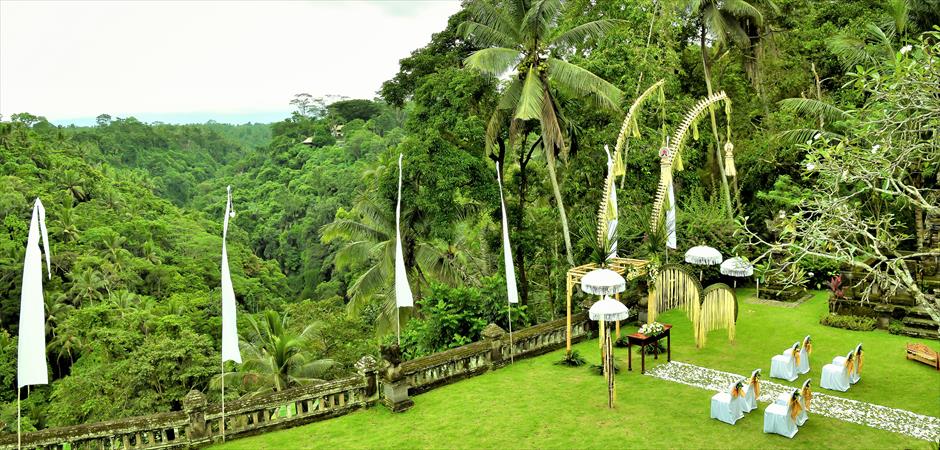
[0,313,589,450]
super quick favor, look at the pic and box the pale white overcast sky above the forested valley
[0,0,460,123]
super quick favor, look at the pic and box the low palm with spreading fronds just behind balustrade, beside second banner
[212,311,336,393]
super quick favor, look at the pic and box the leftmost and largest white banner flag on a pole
[16,198,52,388]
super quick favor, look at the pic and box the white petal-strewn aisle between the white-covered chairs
[646,361,940,442]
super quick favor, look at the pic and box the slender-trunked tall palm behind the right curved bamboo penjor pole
[688,0,776,216]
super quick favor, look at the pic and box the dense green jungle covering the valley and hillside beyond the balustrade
[0,0,940,432]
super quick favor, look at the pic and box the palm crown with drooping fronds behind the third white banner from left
[320,194,459,334]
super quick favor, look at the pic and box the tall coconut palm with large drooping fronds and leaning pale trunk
[460,0,622,266]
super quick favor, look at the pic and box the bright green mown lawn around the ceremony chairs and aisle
[217,290,940,449]
